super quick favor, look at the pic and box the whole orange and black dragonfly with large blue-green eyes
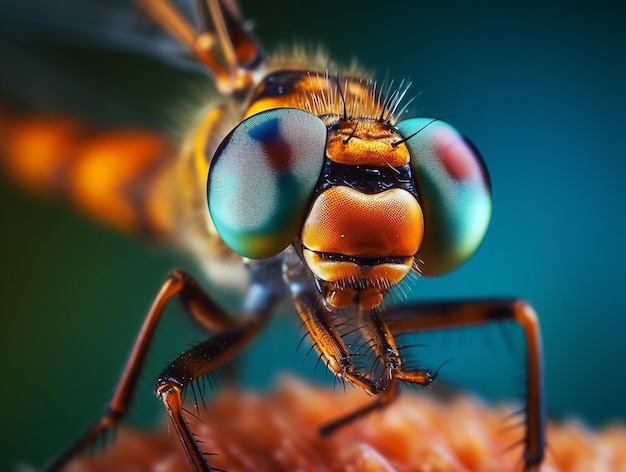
[3,0,545,471]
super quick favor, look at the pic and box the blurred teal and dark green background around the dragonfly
[0,0,626,470]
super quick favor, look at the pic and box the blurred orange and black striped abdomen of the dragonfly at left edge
[0,110,176,239]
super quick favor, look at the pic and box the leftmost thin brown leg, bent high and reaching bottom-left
[47,270,235,472]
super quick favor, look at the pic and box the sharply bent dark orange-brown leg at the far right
[385,299,546,471]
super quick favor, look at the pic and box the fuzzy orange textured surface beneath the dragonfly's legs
[63,379,626,472]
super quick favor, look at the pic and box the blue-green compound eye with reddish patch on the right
[397,118,491,276]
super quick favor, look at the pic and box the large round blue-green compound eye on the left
[207,108,326,259]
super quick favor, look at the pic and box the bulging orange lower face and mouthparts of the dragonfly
[302,186,424,309]
